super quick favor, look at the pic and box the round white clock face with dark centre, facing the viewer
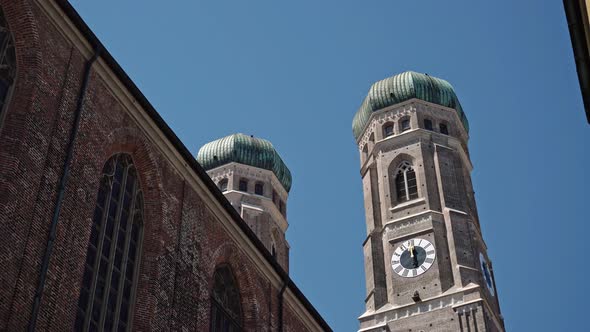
[391,239,436,278]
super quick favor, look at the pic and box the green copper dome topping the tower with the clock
[352,71,469,139]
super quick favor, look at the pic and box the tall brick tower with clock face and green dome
[352,72,504,332]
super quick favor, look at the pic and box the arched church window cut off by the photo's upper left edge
[0,8,16,123]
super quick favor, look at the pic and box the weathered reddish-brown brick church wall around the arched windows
[0,0,326,331]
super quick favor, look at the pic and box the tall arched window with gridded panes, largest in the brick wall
[75,154,143,331]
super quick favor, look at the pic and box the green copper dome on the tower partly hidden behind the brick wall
[197,134,291,192]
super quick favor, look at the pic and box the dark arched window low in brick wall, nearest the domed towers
[209,265,242,332]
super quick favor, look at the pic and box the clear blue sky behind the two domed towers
[72,0,590,331]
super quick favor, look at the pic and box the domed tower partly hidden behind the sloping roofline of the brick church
[197,134,291,272]
